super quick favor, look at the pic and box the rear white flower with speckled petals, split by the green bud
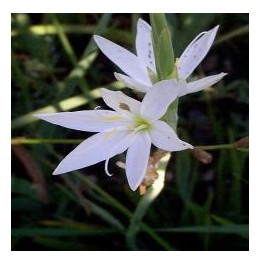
[94,19,226,96]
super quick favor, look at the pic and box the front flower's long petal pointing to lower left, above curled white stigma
[53,131,129,175]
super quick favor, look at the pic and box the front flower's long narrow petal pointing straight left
[35,110,126,132]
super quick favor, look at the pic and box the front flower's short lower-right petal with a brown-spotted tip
[150,120,193,151]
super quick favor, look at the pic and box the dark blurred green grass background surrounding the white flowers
[11,14,248,250]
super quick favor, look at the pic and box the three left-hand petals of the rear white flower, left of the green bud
[94,19,156,92]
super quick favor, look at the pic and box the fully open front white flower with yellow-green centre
[36,80,193,190]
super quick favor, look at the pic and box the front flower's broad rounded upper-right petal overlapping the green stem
[141,80,181,120]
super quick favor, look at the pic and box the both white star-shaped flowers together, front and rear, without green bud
[36,19,226,190]
